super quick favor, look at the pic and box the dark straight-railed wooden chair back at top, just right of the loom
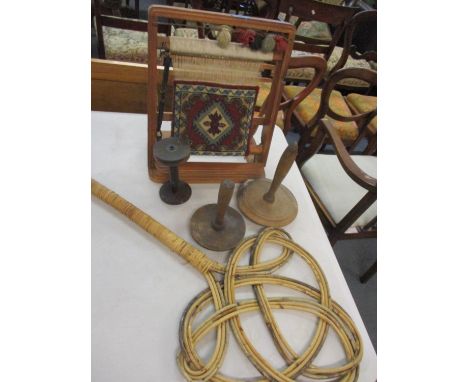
[276,0,359,60]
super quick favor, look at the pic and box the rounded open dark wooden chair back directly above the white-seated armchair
[298,68,377,163]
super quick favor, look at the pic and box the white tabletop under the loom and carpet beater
[91,112,377,382]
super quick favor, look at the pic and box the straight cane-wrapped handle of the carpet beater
[91,179,216,273]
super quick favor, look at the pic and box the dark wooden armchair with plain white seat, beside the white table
[298,118,377,245]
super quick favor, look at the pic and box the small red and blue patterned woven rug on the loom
[173,81,258,155]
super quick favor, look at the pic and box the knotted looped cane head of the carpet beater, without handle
[178,228,362,382]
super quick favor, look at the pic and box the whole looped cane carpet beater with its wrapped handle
[92,181,363,382]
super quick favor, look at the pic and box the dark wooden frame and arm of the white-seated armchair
[298,118,377,245]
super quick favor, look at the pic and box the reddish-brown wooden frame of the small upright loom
[147,5,295,183]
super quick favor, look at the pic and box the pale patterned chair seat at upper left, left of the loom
[102,26,148,64]
